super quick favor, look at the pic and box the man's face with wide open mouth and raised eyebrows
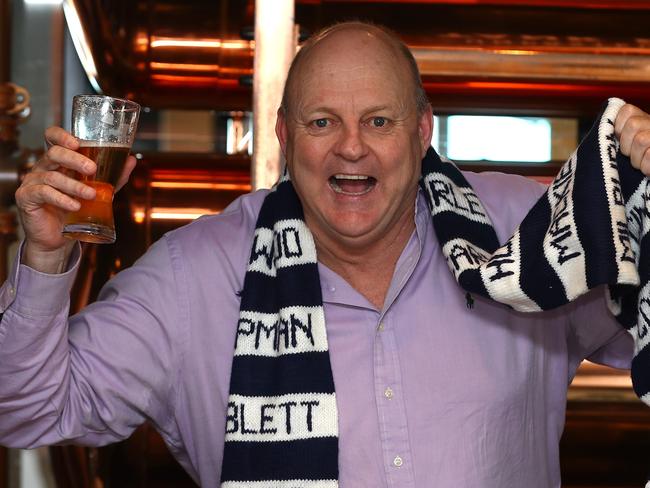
[276,30,432,254]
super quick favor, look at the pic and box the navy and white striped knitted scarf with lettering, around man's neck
[221,99,650,488]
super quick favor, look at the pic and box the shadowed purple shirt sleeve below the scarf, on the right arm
[568,286,634,374]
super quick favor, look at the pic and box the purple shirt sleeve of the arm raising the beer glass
[0,238,184,448]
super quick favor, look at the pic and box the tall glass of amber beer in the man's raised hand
[63,95,140,243]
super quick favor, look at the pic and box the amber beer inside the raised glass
[64,141,130,243]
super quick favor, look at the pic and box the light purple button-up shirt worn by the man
[0,170,632,488]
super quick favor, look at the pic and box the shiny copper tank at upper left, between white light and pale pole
[69,0,254,110]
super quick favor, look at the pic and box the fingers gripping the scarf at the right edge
[614,104,650,175]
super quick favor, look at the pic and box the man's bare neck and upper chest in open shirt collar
[314,207,415,310]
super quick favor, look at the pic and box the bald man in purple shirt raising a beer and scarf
[0,23,650,488]
